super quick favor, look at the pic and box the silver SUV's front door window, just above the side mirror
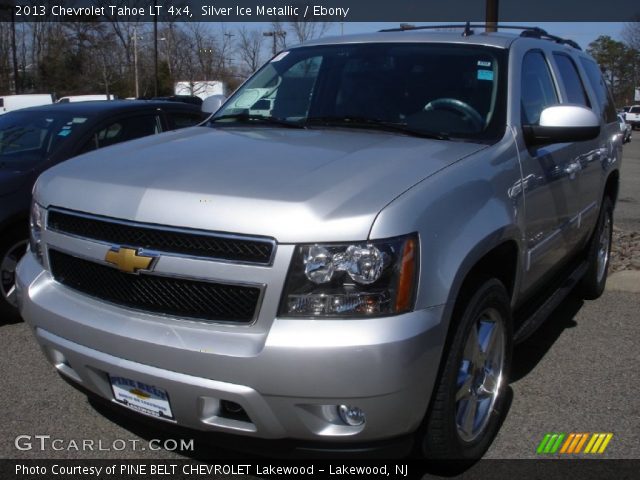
[521,51,558,125]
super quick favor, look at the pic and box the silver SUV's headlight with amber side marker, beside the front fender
[280,235,418,317]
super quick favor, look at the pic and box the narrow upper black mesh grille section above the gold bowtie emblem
[47,210,274,265]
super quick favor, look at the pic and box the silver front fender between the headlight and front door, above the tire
[370,135,524,316]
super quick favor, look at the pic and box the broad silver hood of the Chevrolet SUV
[36,127,485,243]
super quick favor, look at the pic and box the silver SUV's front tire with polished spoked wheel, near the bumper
[422,278,513,460]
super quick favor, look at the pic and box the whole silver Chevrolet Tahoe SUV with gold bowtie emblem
[17,28,622,458]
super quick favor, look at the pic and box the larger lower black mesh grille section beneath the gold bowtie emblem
[49,249,260,323]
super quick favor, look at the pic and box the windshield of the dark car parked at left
[0,111,87,164]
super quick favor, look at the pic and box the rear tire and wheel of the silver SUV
[578,196,613,300]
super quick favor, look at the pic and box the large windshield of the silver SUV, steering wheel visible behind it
[210,43,506,141]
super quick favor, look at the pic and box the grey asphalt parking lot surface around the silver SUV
[0,137,640,459]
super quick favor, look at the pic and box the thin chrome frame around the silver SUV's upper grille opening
[44,207,278,267]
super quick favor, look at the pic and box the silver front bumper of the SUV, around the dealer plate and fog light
[16,254,446,443]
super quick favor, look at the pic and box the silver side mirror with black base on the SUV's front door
[522,105,600,145]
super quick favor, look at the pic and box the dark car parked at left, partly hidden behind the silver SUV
[0,100,205,320]
